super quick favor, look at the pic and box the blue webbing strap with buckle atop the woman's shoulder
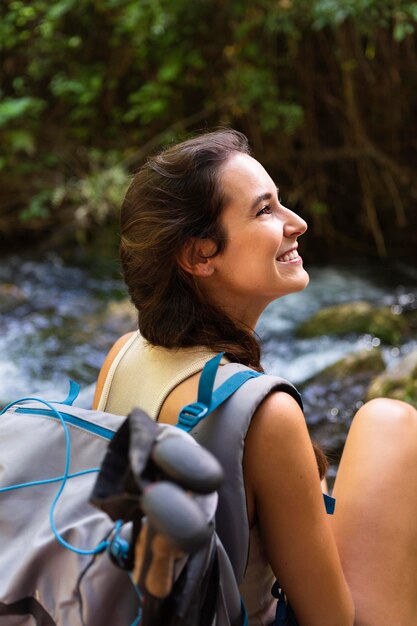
[177,352,262,432]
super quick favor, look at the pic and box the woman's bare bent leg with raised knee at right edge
[332,399,417,626]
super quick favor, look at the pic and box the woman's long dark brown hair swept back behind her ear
[120,129,325,473]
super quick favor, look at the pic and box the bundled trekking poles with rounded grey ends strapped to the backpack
[91,409,223,626]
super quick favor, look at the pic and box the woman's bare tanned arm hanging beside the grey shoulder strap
[244,392,354,626]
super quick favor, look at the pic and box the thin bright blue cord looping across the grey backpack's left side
[0,397,109,555]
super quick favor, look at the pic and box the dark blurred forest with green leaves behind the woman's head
[0,0,417,260]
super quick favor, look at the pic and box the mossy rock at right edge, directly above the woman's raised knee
[366,348,417,408]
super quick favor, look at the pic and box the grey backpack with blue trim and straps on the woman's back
[0,355,306,626]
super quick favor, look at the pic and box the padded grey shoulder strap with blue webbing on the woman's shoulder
[178,355,302,584]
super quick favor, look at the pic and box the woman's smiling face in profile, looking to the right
[201,153,309,328]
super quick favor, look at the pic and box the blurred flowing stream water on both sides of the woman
[0,254,417,470]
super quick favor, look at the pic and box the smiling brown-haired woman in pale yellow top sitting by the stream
[95,130,417,626]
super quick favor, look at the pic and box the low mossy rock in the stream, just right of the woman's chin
[296,300,407,345]
